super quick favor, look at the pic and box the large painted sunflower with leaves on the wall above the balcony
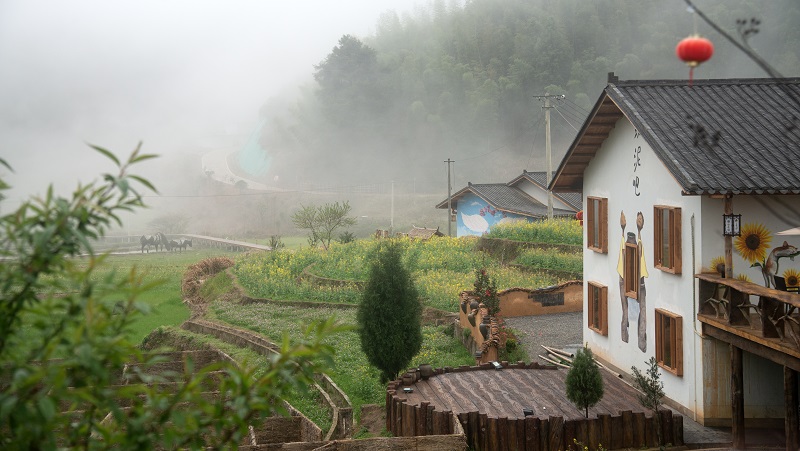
[734,222,800,288]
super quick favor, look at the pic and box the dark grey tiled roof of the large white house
[552,74,800,194]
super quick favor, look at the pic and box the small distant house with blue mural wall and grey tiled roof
[436,171,580,236]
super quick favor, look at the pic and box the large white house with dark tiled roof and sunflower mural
[551,75,800,449]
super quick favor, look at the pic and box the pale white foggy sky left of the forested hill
[0,0,424,201]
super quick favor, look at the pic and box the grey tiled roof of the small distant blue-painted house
[436,183,575,218]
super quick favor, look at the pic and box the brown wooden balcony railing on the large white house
[695,273,800,357]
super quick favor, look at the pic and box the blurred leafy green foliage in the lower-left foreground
[0,147,338,449]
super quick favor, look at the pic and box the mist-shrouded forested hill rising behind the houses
[262,0,800,192]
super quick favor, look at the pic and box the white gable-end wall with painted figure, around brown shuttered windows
[583,118,702,416]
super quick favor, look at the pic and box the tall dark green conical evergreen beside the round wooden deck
[357,240,422,383]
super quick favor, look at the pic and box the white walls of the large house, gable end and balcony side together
[584,118,800,424]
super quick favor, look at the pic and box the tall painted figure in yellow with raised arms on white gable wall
[617,211,648,352]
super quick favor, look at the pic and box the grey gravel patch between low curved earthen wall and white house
[505,312,583,363]
